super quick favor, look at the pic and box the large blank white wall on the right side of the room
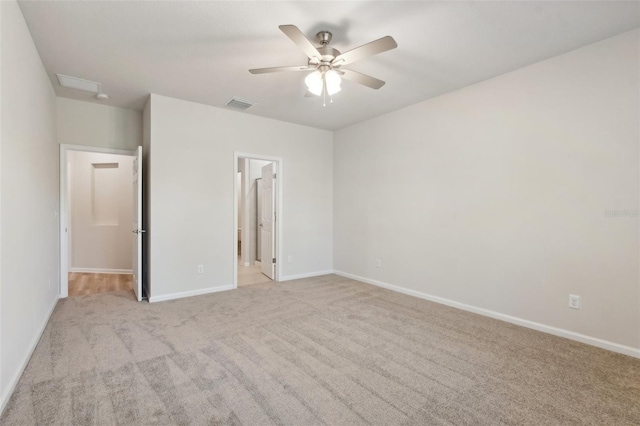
[334,30,640,355]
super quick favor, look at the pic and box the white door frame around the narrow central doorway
[232,151,284,289]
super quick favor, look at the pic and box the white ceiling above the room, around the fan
[20,1,640,130]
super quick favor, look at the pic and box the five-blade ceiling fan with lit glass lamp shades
[249,25,398,105]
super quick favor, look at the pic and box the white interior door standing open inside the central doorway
[260,163,276,280]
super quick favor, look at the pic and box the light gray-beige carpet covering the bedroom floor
[0,275,640,425]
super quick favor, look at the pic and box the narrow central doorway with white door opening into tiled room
[234,153,282,288]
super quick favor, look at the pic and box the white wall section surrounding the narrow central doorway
[149,94,333,300]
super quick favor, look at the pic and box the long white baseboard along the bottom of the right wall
[333,271,640,358]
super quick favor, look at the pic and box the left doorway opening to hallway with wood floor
[60,145,141,300]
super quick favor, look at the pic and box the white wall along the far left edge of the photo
[0,1,59,408]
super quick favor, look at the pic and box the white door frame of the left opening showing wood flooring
[59,144,136,299]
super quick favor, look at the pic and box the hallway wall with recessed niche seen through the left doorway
[68,151,134,273]
